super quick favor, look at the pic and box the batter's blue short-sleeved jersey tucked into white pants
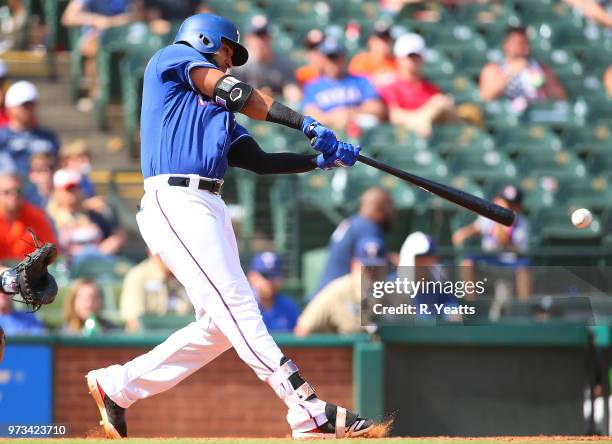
[140,44,249,179]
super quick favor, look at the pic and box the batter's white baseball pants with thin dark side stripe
[96,175,326,431]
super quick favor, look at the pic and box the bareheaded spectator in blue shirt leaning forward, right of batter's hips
[317,188,395,291]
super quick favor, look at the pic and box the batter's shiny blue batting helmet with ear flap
[174,14,249,66]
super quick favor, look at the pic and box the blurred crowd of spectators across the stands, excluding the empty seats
[0,0,612,335]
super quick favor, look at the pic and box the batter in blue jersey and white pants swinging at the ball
[87,14,377,438]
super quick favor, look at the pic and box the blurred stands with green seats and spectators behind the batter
[0,0,612,335]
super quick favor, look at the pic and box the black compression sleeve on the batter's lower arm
[227,136,317,174]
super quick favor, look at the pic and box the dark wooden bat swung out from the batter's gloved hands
[357,154,516,227]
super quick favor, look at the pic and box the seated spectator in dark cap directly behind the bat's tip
[452,185,531,299]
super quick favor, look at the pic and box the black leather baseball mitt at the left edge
[1,236,57,311]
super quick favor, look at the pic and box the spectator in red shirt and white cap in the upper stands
[380,33,453,137]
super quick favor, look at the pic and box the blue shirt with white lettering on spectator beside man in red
[303,75,379,112]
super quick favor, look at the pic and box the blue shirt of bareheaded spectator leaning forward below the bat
[316,215,384,293]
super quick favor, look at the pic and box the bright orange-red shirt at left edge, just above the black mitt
[0,202,57,260]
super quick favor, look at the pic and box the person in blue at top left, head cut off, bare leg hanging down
[62,0,132,110]
